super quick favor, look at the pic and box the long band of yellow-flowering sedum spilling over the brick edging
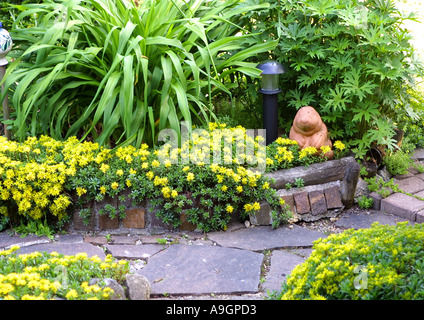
[0,123,345,231]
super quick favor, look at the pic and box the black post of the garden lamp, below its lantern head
[260,90,281,145]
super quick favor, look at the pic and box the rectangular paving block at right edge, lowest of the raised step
[381,193,424,221]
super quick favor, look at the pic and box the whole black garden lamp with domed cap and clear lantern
[257,60,286,145]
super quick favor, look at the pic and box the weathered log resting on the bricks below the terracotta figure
[266,157,358,189]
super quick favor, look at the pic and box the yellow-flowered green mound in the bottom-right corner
[273,222,424,300]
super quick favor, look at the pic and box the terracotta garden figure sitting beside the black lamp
[289,106,333,159]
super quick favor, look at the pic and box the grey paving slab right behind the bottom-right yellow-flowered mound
[335,211,407,229]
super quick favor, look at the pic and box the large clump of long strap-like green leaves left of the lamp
[0,0,276,147]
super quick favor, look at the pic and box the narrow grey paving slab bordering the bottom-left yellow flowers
[17,243,106,259]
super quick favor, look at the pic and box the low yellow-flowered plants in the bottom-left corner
[0,246,129,300]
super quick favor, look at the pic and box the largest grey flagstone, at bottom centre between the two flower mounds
[137,244,263,295]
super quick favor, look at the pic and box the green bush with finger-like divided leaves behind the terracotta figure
[238,0,422,157]
